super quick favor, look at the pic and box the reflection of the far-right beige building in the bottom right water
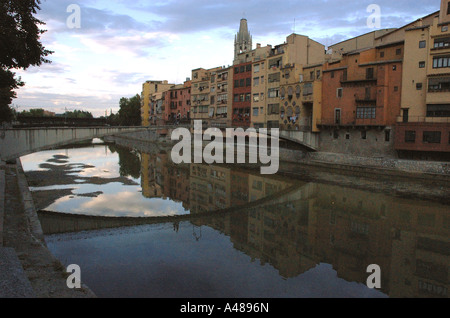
[391,200,450,297]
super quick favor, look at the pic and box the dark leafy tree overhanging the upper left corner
[0,0,53,122]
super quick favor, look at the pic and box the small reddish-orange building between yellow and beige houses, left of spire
[163,78,191,124]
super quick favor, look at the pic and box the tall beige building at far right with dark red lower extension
[395,0,450,161]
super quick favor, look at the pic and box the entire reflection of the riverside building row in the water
[142,158,450,297]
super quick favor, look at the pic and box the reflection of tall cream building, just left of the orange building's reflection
[242,184,317,278]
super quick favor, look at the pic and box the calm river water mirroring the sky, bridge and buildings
[21,140,450,298]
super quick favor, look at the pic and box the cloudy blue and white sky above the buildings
[13,0,440,116]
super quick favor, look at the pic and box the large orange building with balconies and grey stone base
[318,41,404,156]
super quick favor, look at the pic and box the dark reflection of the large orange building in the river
[313,185,393,291]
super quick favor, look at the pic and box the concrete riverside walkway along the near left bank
[0,160,95,298]
